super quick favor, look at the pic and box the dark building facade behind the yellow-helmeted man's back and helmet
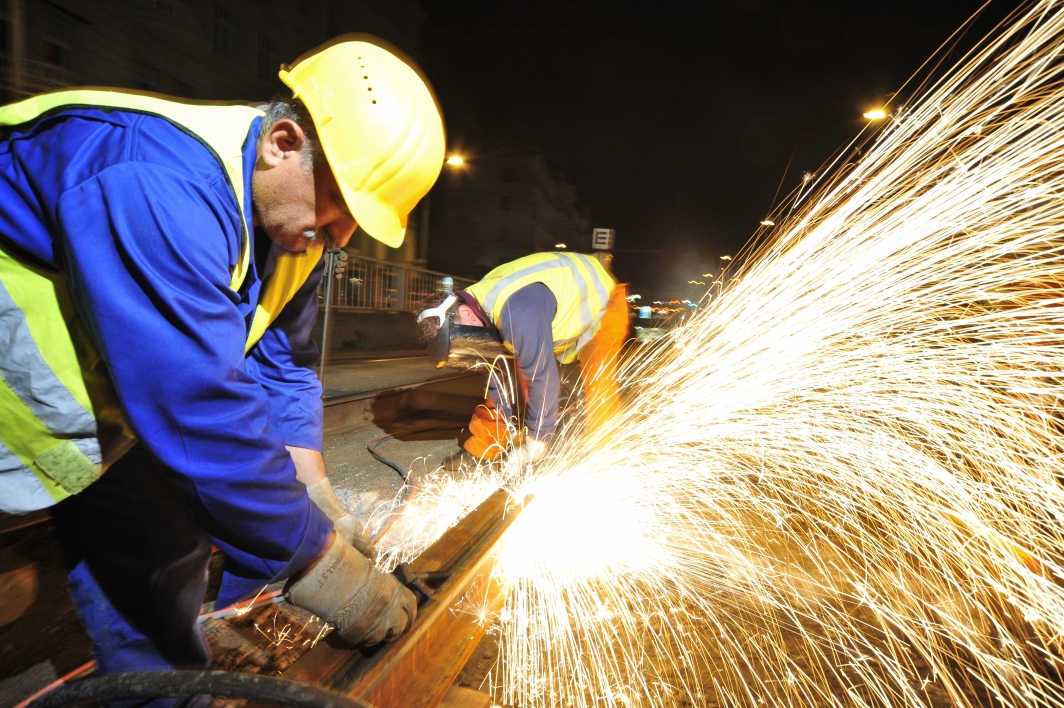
[0,0,428,262]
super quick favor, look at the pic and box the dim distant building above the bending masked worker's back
[429,144,591,277]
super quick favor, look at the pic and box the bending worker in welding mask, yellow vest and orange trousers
[417,252,628,470]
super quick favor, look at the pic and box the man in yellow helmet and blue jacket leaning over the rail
[0,35,445,685]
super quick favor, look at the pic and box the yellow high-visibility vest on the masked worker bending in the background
[466,253,615,364]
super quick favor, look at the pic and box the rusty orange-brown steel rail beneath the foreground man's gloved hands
[284,490,523,708]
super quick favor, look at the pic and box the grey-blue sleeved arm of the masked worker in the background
[499,283,562,442]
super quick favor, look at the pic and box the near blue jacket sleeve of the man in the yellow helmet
[56,162,331,602]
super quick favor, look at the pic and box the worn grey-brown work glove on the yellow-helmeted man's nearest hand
[284,534,417,646]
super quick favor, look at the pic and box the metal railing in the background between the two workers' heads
[318,254,476,312]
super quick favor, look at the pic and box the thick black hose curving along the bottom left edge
[27,671,373,708]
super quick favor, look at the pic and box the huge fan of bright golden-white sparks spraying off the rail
[383,1,1064,708]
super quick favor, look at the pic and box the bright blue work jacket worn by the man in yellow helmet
[0,108,332,605]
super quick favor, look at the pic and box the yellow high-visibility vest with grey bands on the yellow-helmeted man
[0,89,321,513]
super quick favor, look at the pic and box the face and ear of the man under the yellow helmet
[251,120,356,252]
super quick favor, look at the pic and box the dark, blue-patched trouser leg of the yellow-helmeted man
[53,445,211,689]
